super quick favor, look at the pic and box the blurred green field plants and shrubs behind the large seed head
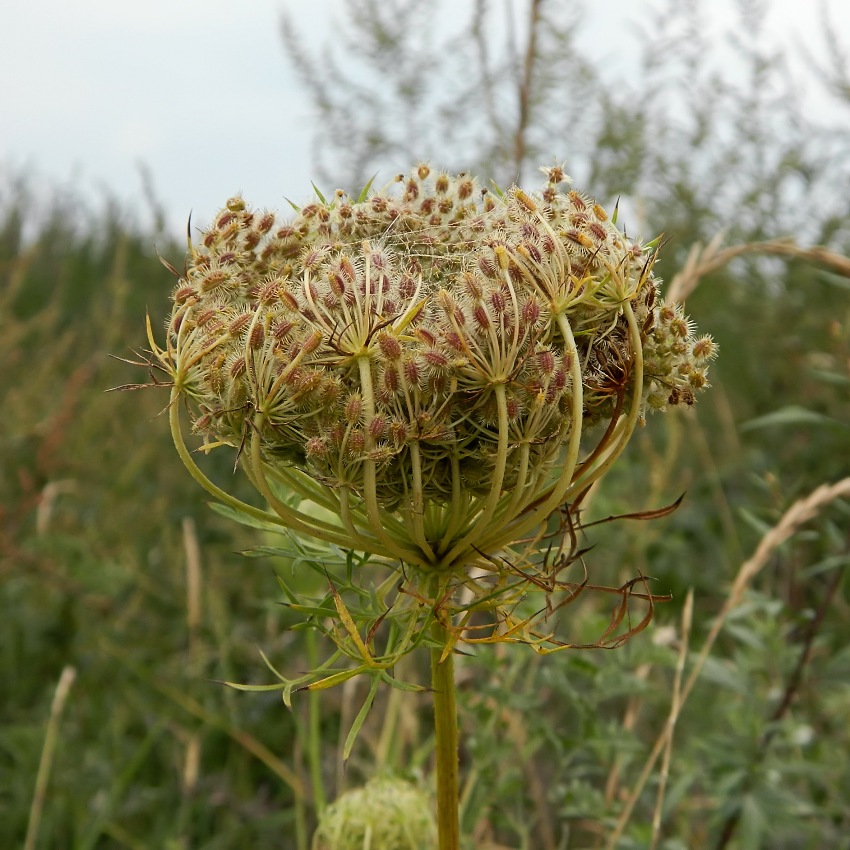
[0,3,850,850]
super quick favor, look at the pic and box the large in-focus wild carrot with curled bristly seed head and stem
[150,165,715,848]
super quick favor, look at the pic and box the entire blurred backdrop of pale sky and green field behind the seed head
[0,0,850,850]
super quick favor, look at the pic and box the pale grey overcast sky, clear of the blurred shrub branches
[0,0,850,238]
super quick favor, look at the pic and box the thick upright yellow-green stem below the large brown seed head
[431,624,460,850]
